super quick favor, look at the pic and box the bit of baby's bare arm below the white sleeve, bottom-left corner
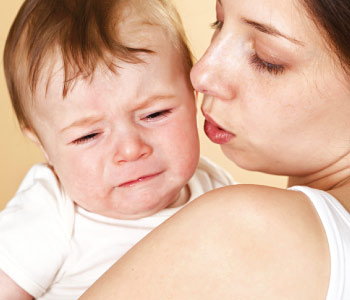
[0,270,34,300]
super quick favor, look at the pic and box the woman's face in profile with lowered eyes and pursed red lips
[191,0,350,175]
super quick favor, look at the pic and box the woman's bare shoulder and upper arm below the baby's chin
[81,185,330,300]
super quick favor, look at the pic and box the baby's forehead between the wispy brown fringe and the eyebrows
[31,54,183,128]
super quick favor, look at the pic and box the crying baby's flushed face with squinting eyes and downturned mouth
[31,25,199,219]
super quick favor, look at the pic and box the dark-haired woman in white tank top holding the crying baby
[82,0,350,300]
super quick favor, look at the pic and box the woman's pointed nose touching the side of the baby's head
[191,35,235,100]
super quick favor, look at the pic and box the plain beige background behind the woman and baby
[0,0,286,209]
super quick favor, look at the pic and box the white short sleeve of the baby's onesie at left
[0,165,74,298]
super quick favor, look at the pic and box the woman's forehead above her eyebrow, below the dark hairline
[217,0,335,57]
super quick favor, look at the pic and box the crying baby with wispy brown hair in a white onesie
[0,0,233,300]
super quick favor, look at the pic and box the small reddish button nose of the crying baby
[113,132,153,164]
